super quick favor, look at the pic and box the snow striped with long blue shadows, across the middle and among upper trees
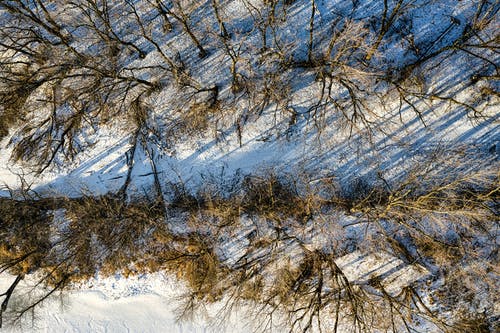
[0,1,500,196]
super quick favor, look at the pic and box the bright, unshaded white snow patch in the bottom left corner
[0,273,251,333]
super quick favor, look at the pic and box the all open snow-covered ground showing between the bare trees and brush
[0,0,500,332]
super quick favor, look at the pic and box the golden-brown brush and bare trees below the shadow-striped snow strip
[0,153,500,332]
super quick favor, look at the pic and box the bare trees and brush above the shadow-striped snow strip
[0,0,498,172]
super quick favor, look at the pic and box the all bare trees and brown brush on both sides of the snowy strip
[0,0,500,332]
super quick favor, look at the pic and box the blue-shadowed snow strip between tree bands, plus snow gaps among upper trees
[0,0,500,196]
